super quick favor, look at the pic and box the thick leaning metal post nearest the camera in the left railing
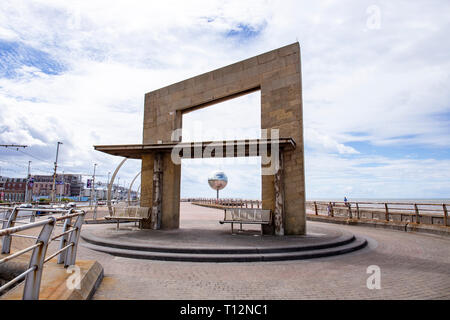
[23,217,56,300]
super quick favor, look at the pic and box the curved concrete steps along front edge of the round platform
[82,237,367,262]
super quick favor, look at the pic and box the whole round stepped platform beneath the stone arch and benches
[81,227,367,262]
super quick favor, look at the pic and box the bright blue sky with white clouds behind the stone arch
[0,0,450,199]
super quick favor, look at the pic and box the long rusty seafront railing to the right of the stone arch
[306,201,450,226]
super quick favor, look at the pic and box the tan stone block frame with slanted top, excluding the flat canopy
[141,42,306,235]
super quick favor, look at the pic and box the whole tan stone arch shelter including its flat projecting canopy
[95,42,306,235]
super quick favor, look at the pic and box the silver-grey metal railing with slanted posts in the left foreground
[0,207,85,300]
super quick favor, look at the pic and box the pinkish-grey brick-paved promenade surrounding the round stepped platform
[78,203,450,299]
